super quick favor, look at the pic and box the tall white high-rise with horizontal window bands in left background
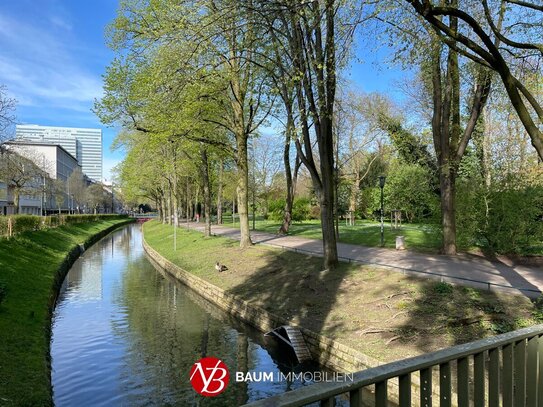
[15,124,102,181]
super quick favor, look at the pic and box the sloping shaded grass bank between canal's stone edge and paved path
[144,221,543,361]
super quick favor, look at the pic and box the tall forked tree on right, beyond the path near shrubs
[376,0,499,254]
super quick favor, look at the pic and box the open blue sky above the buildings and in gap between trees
[0,0,404,180]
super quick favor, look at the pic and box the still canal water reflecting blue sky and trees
[51,225,340,406]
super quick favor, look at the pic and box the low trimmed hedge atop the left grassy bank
[0,214,128,237]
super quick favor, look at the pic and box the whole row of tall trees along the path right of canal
[99,0,543,268]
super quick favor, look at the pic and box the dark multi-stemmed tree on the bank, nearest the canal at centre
[255,0,362,269]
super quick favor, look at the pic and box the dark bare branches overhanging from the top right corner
[406,0,543,160]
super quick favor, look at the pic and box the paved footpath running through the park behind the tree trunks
[184,222,543,298]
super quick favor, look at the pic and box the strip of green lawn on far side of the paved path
[253,220,441,252]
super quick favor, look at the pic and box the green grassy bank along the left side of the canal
[0,219,133,406]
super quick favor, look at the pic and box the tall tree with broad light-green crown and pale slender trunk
[97,0,268,247]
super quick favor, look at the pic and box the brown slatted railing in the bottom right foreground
[246,325,543,407]
